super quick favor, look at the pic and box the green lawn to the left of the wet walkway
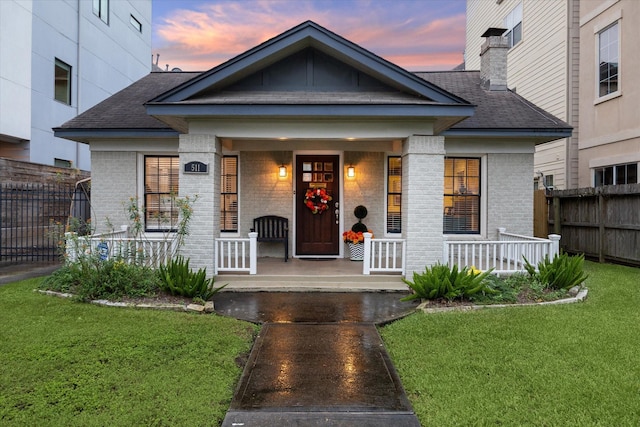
[0,279,256,426]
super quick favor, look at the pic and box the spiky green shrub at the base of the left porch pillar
[158,255,227,301]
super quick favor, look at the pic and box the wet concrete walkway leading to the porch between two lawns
[214,292,420,427]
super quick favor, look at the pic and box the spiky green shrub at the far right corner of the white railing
[524,253,589,290]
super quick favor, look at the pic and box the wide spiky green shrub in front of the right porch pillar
[402,263,495,301]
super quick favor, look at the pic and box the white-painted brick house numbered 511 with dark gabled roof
[55,22,571,275]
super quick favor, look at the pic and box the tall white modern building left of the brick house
[0,0,151,170]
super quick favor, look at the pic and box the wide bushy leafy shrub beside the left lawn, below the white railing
[41,256,159,301]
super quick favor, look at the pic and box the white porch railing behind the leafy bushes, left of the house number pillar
[65,226,177,268]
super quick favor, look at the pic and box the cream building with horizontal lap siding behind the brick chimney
[465,0,582,189]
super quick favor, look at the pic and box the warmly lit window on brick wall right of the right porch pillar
[443,157,480,234]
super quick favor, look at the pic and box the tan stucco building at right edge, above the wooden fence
[579,0,640,187]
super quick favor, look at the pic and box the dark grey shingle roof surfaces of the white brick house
[55,71,571,138]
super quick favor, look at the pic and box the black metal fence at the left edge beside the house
[0,182,91,265]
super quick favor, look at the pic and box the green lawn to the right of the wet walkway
[381,263,640,426]
